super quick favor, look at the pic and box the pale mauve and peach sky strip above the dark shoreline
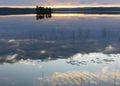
[0,0,120,6]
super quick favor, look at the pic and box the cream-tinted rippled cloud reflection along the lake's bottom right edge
[36,68,120,86]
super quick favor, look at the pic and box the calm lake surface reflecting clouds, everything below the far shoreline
[0,14,120,86]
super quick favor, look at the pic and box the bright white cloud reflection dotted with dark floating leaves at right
[67,53,120,66]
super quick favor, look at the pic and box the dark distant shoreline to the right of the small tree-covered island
[53,7,120,14]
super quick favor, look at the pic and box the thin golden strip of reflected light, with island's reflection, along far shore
[0,13,120,20]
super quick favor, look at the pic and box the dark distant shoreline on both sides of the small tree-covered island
[0,7,120,15]
